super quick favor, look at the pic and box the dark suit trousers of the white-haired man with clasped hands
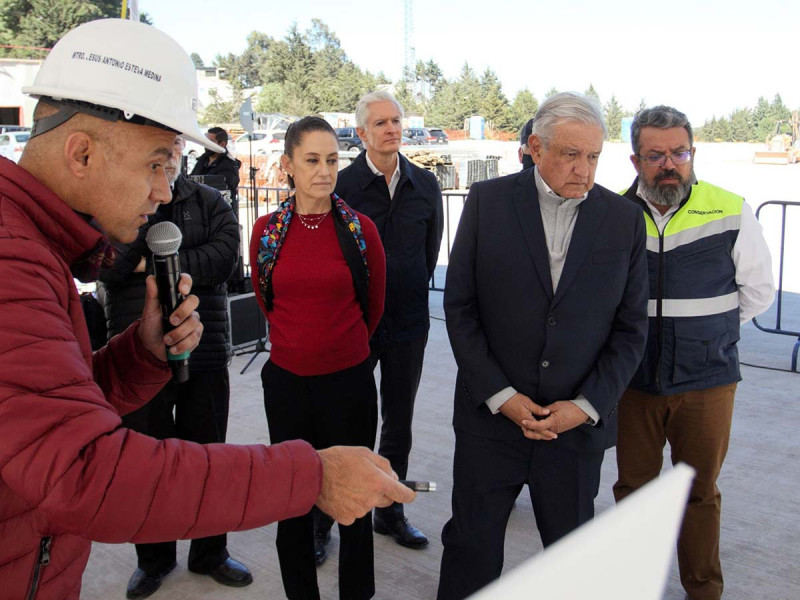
[438,428,604,600]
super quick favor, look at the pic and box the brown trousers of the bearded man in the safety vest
[614,383,736,600]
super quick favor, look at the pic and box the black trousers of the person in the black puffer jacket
[122,368,230,574]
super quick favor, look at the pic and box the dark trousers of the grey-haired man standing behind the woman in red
[370,333,428,479]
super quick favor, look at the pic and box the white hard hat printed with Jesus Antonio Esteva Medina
[22,19,225,152]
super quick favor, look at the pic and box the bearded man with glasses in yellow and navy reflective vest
[614,106,775,600]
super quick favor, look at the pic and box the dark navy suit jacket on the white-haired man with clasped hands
[444,169,648,452]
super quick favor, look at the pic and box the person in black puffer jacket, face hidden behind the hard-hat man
[98,138,252,599]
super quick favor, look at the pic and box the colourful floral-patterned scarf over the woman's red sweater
[257,194,369,319]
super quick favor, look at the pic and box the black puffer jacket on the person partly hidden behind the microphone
[99,175,239,370]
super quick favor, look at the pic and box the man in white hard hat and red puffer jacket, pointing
[0,19,414,600]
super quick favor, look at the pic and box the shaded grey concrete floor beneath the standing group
[81,292,800,600]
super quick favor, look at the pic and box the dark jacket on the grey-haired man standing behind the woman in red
[336,151,444,345]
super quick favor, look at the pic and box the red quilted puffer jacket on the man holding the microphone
[0,158,322,600]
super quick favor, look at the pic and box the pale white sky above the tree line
[145,0,800,125]
